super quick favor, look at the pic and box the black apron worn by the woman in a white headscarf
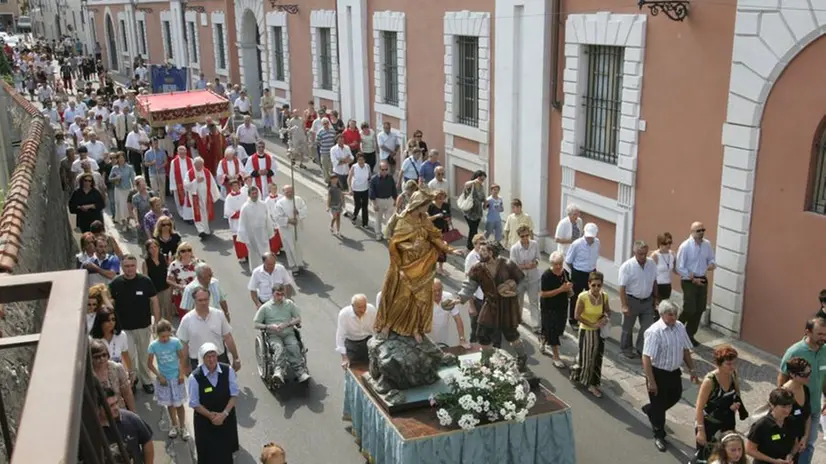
[192,363,239,464]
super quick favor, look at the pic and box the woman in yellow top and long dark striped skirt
[571,272,611,398]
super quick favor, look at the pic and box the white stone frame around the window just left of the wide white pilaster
[443,11,491,145]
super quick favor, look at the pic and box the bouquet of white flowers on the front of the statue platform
[430,349,536,430]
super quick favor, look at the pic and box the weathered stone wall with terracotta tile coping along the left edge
[0,83,77,463]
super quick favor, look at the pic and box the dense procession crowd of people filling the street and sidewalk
[7,35,826,464]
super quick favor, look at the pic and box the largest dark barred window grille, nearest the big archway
[580,45,625,164]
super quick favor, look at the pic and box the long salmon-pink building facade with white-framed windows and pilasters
[74,0,826,353]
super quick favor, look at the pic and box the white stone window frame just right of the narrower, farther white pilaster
[373,11,407,121]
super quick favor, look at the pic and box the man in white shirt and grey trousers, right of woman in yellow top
[618,240,657,359]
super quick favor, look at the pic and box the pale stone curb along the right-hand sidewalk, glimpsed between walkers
[264,138,694,458]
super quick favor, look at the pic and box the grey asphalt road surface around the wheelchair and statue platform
[114,168,685,464]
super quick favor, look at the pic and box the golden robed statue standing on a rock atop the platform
[375,190,463,342]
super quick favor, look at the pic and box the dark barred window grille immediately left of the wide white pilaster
[454,36,479,127]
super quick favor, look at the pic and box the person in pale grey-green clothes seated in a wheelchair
[253,284,310,385]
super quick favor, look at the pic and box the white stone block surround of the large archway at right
[710,0,826,334]
